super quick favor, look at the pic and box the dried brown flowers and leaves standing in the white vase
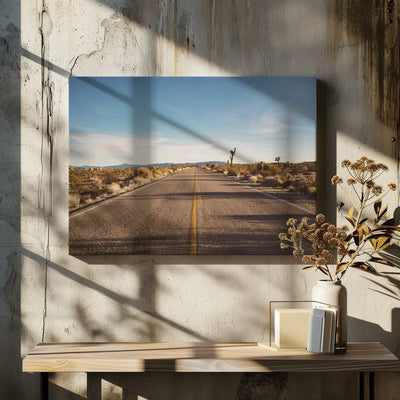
[279,157,400,281]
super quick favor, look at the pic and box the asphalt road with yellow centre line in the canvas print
[69,167,309,255]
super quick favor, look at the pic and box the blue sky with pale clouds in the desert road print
[69,77,316,166]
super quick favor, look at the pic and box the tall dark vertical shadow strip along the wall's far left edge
[0,1,34,399]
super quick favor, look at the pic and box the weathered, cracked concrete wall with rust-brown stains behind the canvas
[0,0,400,400]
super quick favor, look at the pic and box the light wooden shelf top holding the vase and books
[23,342,400,372]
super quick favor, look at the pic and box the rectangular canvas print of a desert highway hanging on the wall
[69,77,316,255]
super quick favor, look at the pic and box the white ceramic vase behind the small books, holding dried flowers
[311,280,347,349]
